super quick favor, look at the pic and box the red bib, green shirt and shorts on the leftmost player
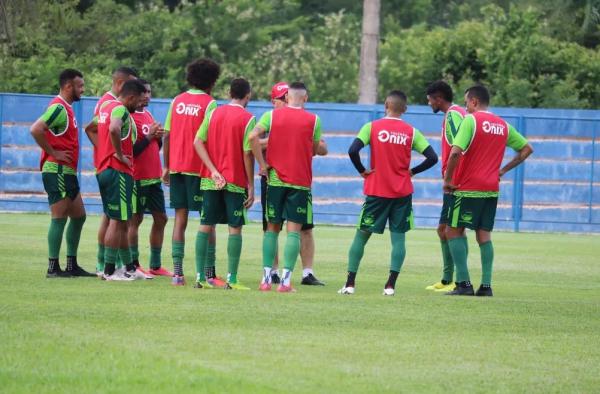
[40,96,79,205]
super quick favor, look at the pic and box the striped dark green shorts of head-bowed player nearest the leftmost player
[96,168,134,220]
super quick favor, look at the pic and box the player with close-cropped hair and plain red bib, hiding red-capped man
[250,82,321,292]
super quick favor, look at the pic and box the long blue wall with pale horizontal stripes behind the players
[0,94,600,232]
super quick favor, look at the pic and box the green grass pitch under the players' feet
[0,214,600,393]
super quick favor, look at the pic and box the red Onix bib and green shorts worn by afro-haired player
[165,89,217,211]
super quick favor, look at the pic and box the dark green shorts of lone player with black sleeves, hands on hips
[358,194,414,234]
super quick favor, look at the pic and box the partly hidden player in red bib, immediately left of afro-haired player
[127,79,173,277]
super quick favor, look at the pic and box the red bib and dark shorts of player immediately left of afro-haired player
[131,109,165,213]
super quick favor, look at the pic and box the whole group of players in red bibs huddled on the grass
[31,59,533,296]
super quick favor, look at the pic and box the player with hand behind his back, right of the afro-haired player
[194,78,256,290]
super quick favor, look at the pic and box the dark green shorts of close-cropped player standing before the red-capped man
[266,185,313,224]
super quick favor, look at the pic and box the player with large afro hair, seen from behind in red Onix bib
[163,59,221,287]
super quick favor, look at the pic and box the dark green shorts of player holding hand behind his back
[200,190,248,227]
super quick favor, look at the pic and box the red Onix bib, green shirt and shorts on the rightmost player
[448,111,527,231]
